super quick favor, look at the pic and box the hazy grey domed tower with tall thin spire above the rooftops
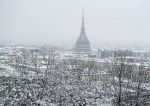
[74,11,91,53]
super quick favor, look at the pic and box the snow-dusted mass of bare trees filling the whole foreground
[0,48,150,106]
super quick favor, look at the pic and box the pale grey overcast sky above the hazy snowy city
[0,0,150,45]
